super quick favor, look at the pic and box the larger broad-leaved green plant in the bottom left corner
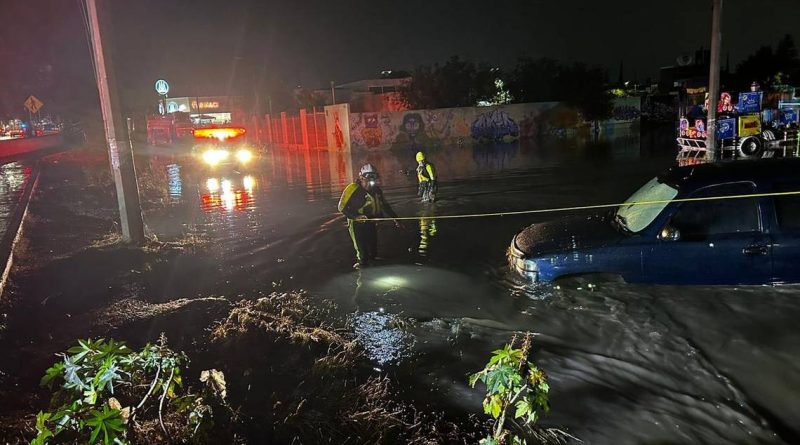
[31,335,224,445]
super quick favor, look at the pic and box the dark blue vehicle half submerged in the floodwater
[509,158,800,285]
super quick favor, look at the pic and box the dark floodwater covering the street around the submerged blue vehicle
[133,126,800,444]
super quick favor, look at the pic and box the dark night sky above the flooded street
[0,0,800,114]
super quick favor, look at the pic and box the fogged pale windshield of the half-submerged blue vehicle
[614,178,678,233]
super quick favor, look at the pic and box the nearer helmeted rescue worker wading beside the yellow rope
[339,164,400,269]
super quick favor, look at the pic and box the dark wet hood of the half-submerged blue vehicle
[514,213,625,257]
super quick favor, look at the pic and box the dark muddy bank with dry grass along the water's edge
[0,152,482,444]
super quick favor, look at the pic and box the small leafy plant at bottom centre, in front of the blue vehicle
[469,334,550,445]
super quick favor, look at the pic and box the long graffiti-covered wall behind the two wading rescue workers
[350,102,564,150]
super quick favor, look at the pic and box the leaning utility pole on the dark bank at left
[86,0,145,246]
